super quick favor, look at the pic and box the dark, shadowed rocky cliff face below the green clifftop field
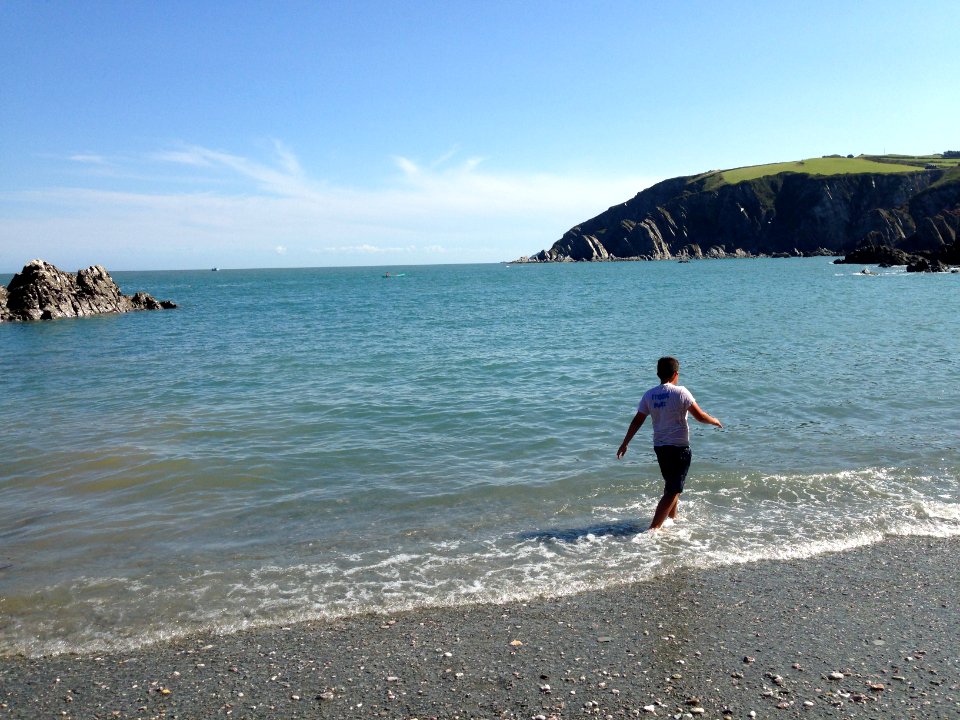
[529,170,960,262]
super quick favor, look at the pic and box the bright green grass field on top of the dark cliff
[698,155,960,190]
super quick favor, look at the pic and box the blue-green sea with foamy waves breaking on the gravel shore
[0,258,960,656]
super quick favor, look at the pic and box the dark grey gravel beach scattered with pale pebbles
[0,537,960,720]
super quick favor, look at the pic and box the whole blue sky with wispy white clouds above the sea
[0,0,960,272]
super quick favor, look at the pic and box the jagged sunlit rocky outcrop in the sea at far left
[0,260,176,322]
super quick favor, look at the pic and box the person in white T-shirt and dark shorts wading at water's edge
[617,357,723,530]
